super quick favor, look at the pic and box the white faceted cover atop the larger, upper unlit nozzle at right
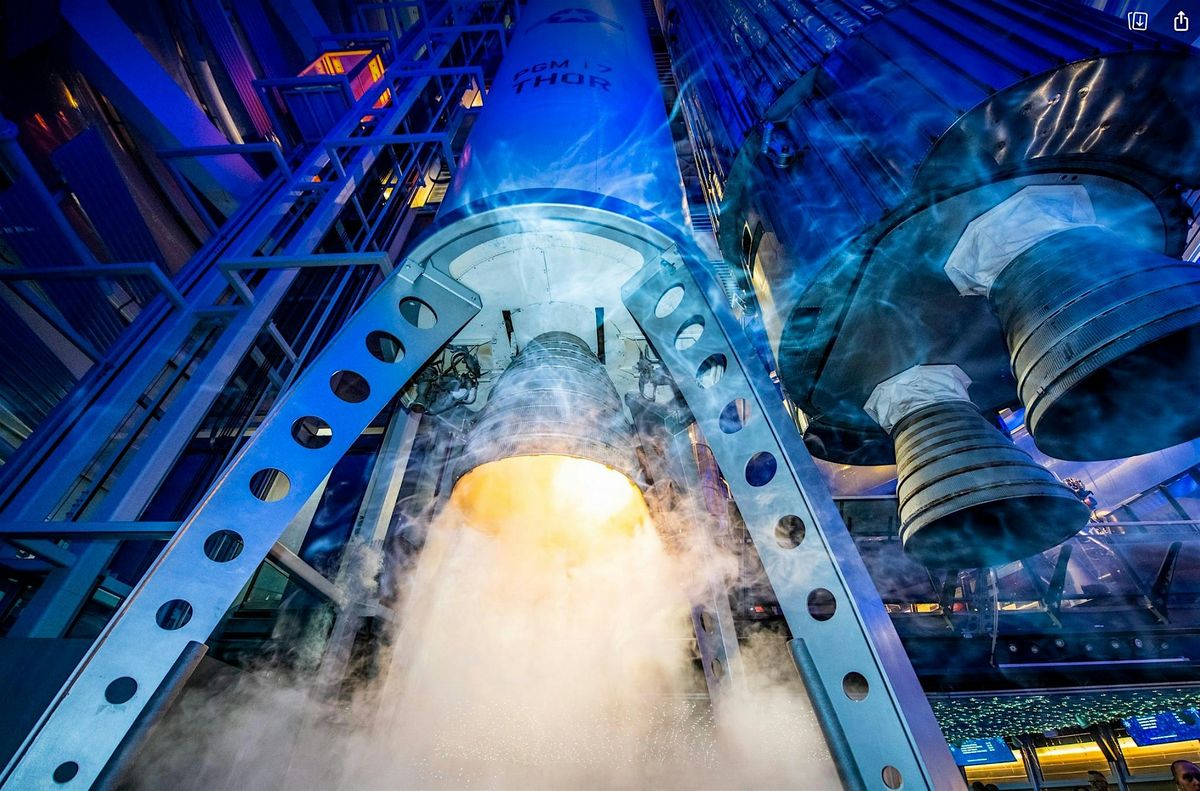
[946,185,1098,296]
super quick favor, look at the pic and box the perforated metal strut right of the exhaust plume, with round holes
[622,248,962,791]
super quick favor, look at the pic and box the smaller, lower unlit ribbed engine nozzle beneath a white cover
[893,401,1088,569]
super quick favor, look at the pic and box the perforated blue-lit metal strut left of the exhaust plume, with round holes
[2,262,480,791]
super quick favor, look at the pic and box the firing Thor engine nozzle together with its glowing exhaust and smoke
[119,335,838,791]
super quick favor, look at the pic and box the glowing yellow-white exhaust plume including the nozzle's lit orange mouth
[331,455,836,789]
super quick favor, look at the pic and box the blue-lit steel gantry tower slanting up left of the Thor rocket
[0,2,506,607]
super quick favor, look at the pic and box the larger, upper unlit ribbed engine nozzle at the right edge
[988,227,1200,460]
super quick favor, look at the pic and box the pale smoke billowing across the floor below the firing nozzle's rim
[119,470,839,791]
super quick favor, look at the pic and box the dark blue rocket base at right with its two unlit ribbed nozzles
[661,0,1200,564]
